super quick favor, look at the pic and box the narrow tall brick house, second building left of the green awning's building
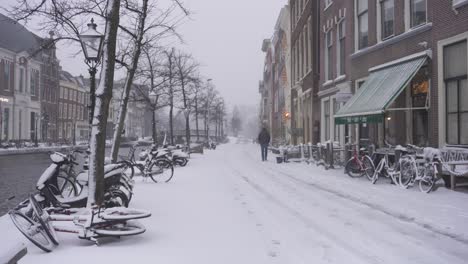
[289,0,321,143]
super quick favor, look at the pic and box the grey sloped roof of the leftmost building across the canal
[0,13,43,53]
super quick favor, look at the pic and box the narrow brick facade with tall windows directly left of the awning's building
[317,0,354,144]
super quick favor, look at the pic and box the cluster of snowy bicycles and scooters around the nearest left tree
[9,144,188,252]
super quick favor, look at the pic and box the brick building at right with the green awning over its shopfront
[334,0,468,146]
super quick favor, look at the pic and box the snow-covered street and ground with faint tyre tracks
[0,141,468,264]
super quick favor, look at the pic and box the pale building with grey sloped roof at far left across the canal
[0,14,49,141]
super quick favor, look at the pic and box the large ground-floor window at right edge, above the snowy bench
[444,40,468,145]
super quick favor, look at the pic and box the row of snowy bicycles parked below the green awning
[345,144,443,193]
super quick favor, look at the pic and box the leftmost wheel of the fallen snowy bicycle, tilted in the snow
[9,211,54,252]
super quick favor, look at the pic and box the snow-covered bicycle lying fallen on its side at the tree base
[9,195,151,252]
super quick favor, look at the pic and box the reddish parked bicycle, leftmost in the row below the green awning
[345,144,375,180]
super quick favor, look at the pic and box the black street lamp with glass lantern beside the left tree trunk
[80,19,104,138]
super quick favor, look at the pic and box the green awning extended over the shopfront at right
[335,55,427,125]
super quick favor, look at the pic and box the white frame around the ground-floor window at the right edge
[437,32,468,148]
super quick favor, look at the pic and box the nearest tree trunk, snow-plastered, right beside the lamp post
[87,0,120,207]
